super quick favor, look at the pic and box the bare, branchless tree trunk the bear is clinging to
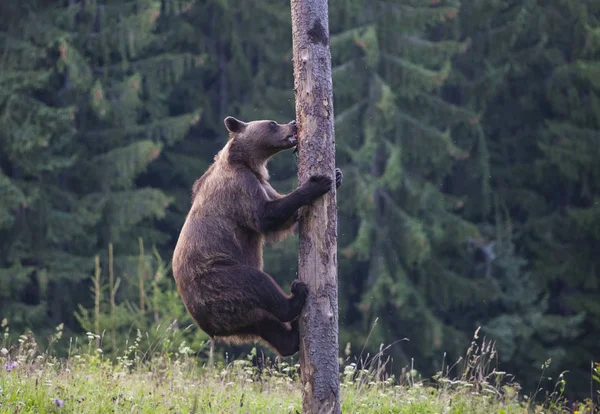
[291,0,341,414]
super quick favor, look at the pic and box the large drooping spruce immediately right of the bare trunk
[331,0,488,373]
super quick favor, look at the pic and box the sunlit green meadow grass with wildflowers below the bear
[0,329,591,414]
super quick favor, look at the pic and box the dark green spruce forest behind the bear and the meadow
[0,0,600,397]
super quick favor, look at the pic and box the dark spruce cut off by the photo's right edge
[527,1,600,397]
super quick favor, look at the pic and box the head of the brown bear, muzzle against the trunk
[224,116,298,164]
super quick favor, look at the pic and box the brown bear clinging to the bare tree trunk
[173,116,342,356]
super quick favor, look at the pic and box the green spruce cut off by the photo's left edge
[0,1,82,334]
